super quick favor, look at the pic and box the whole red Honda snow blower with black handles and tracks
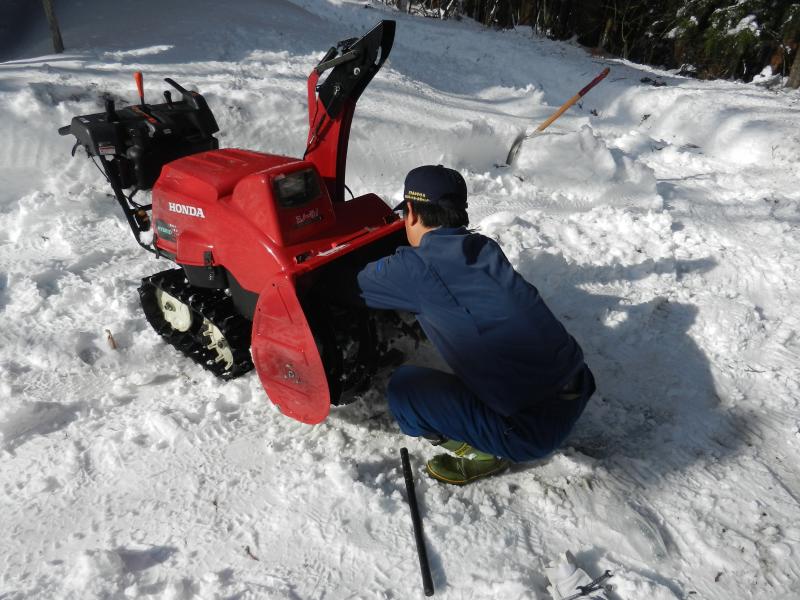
[59,21,408,423]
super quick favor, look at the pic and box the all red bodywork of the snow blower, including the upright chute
[153,21,405,424]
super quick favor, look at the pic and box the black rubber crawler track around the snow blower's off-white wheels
[139,269,253,380]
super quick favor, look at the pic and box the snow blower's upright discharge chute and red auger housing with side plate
[251,21,402,424]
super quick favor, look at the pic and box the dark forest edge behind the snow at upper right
[385,0,800,88]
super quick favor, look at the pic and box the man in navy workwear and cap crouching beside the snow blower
[358,165,595,484]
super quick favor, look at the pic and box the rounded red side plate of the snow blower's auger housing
[251,274,331,425]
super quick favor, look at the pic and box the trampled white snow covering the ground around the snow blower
[0,0,800,600]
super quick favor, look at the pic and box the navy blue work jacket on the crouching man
[358,227,583,416]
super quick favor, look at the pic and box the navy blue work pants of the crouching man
[387,365,594,462]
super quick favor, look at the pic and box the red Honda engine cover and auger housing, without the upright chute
[153,149,405,424]
